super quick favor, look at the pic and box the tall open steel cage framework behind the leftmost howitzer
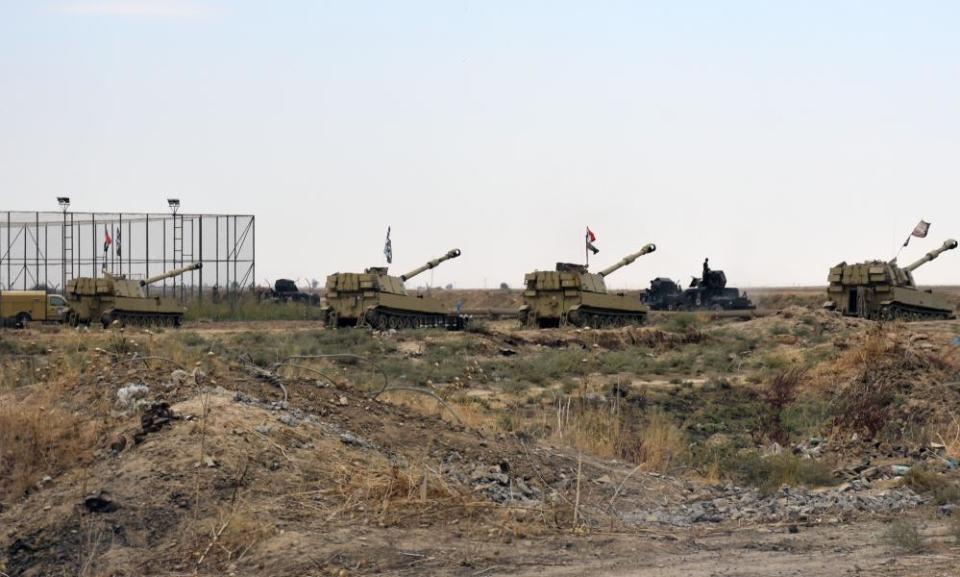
[0,211,256,299]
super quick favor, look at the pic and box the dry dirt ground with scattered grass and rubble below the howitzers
[0,307,960,577]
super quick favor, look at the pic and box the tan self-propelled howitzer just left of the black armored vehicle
[519,244,656,328]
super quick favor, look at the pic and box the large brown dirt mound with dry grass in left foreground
[0,355,683,576]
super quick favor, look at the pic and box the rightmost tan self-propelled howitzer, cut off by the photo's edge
[826,240,957,321]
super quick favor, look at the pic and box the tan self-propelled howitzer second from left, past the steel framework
[323,248,465,330]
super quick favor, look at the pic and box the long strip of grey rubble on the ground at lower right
[622,484,925,527]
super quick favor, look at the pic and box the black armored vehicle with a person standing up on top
[643,263,756,311]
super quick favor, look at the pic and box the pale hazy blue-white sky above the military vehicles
[0,0,960,288]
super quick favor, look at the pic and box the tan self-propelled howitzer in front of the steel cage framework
[66,262,203,328]
